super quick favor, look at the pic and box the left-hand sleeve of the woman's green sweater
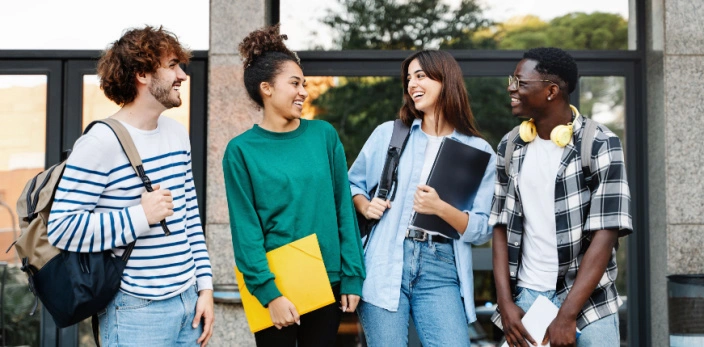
[222,145,281,306]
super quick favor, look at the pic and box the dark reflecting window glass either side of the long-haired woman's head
[303,76,518,169]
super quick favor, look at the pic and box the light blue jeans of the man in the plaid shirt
[516,287,620,347]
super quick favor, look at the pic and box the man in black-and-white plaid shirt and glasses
[489,48,632,347]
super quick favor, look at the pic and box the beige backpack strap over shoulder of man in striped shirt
[83,118,171,239]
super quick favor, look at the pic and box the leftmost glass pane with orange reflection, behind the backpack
[0,75,47,346]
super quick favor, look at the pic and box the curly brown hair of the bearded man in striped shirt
[98,25,191,106]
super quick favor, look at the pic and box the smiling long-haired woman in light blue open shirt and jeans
[349,51,496,347]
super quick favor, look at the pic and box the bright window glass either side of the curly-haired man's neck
[83,75,191,130]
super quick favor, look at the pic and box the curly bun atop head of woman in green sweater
[239,24,299,67]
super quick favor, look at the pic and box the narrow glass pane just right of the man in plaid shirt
[579,76,633,342]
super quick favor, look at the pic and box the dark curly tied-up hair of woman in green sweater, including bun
[239,24,301,107]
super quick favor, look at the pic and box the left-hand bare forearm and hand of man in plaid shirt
[492,225,537,347]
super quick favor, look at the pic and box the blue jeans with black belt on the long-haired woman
[357,239,471,347]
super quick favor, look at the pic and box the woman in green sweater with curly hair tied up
[223,26,365,347]
